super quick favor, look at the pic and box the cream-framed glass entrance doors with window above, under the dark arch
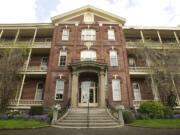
[79,81,98,107]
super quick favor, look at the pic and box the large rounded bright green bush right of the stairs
[139,100,164,118]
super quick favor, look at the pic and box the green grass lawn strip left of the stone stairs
[0,119,48,128]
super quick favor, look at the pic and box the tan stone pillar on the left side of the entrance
[71,72,78,108]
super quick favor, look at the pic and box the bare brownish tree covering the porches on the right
[133,44,180,107]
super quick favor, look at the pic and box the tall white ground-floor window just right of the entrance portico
[112,80,121,101]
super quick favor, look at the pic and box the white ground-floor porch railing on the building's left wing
[9,99,43,106]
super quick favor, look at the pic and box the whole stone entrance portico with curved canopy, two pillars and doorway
[69,59,107,108]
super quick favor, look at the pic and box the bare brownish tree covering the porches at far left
[0,49,26,112]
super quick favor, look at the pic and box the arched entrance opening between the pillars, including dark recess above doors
[78,72,99,107]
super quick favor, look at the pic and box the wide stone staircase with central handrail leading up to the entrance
[52,108,121,128]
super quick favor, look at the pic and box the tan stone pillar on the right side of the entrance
[99,71,106,108]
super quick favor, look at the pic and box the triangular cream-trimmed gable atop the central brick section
[51,6,125,25]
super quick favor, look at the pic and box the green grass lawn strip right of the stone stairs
[131,119,180,127]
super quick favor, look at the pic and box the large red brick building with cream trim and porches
[0,6,180,109]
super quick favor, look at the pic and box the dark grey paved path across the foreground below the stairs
[0,126,180,135]
